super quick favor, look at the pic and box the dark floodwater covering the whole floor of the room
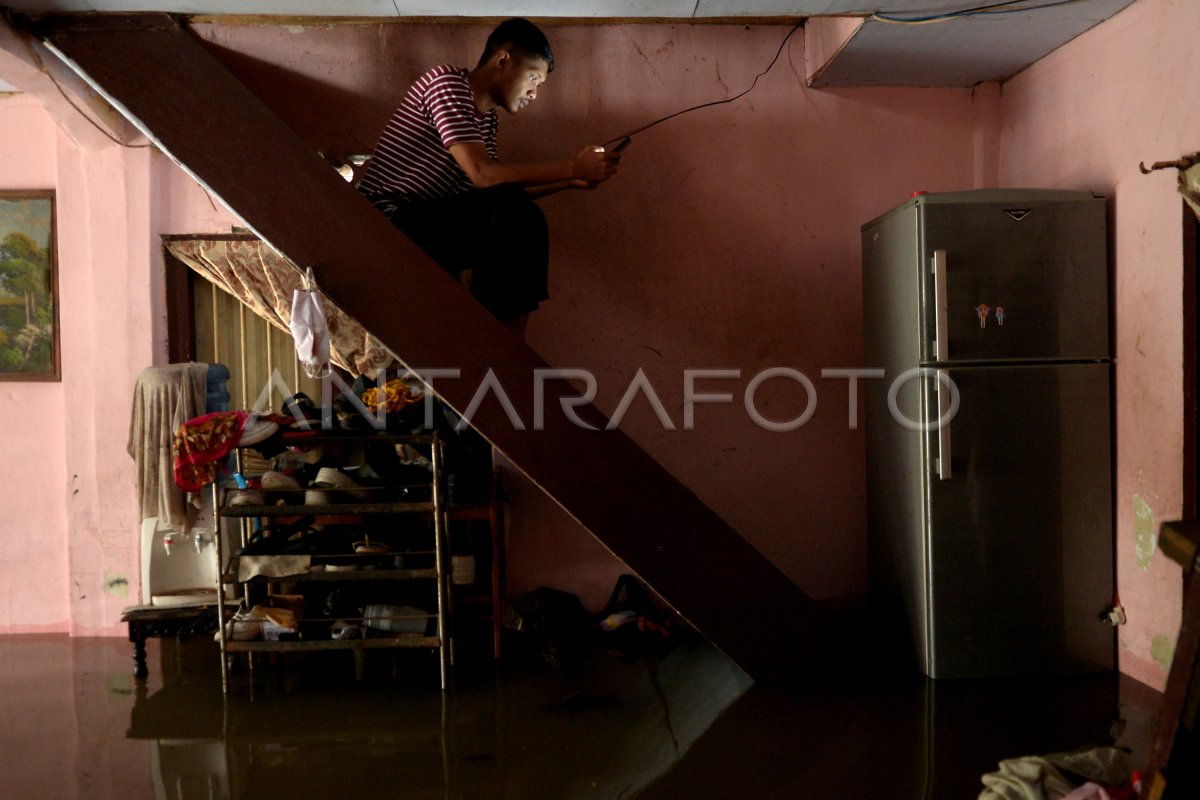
[0,636,1160,800]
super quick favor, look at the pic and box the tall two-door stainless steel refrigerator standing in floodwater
[862,190,1115,678]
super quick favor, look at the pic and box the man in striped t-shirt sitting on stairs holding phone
[359,19,620,332]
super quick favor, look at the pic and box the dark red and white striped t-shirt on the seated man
[359,65,498,213]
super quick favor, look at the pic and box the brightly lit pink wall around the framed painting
[0,84,233,634]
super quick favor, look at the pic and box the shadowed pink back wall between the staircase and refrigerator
[199,25,977,607]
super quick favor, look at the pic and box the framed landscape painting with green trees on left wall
[0,192,61,380]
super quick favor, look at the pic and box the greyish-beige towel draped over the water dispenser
[126,362,209,530]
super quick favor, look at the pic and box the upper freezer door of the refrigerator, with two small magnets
[916,197,1109,363]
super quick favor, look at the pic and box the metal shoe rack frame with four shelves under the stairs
[212,432,454,694]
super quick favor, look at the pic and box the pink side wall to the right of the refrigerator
[1000,0,1200,686]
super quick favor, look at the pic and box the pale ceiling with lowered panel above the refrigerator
[0,0,1134,91]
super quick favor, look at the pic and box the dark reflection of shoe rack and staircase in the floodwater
[126,640,750,800]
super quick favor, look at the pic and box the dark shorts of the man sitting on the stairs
[376,184,550,323]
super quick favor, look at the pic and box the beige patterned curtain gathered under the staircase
[167,239,397,375]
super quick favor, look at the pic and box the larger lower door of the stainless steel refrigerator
[922,363,1115,678]
